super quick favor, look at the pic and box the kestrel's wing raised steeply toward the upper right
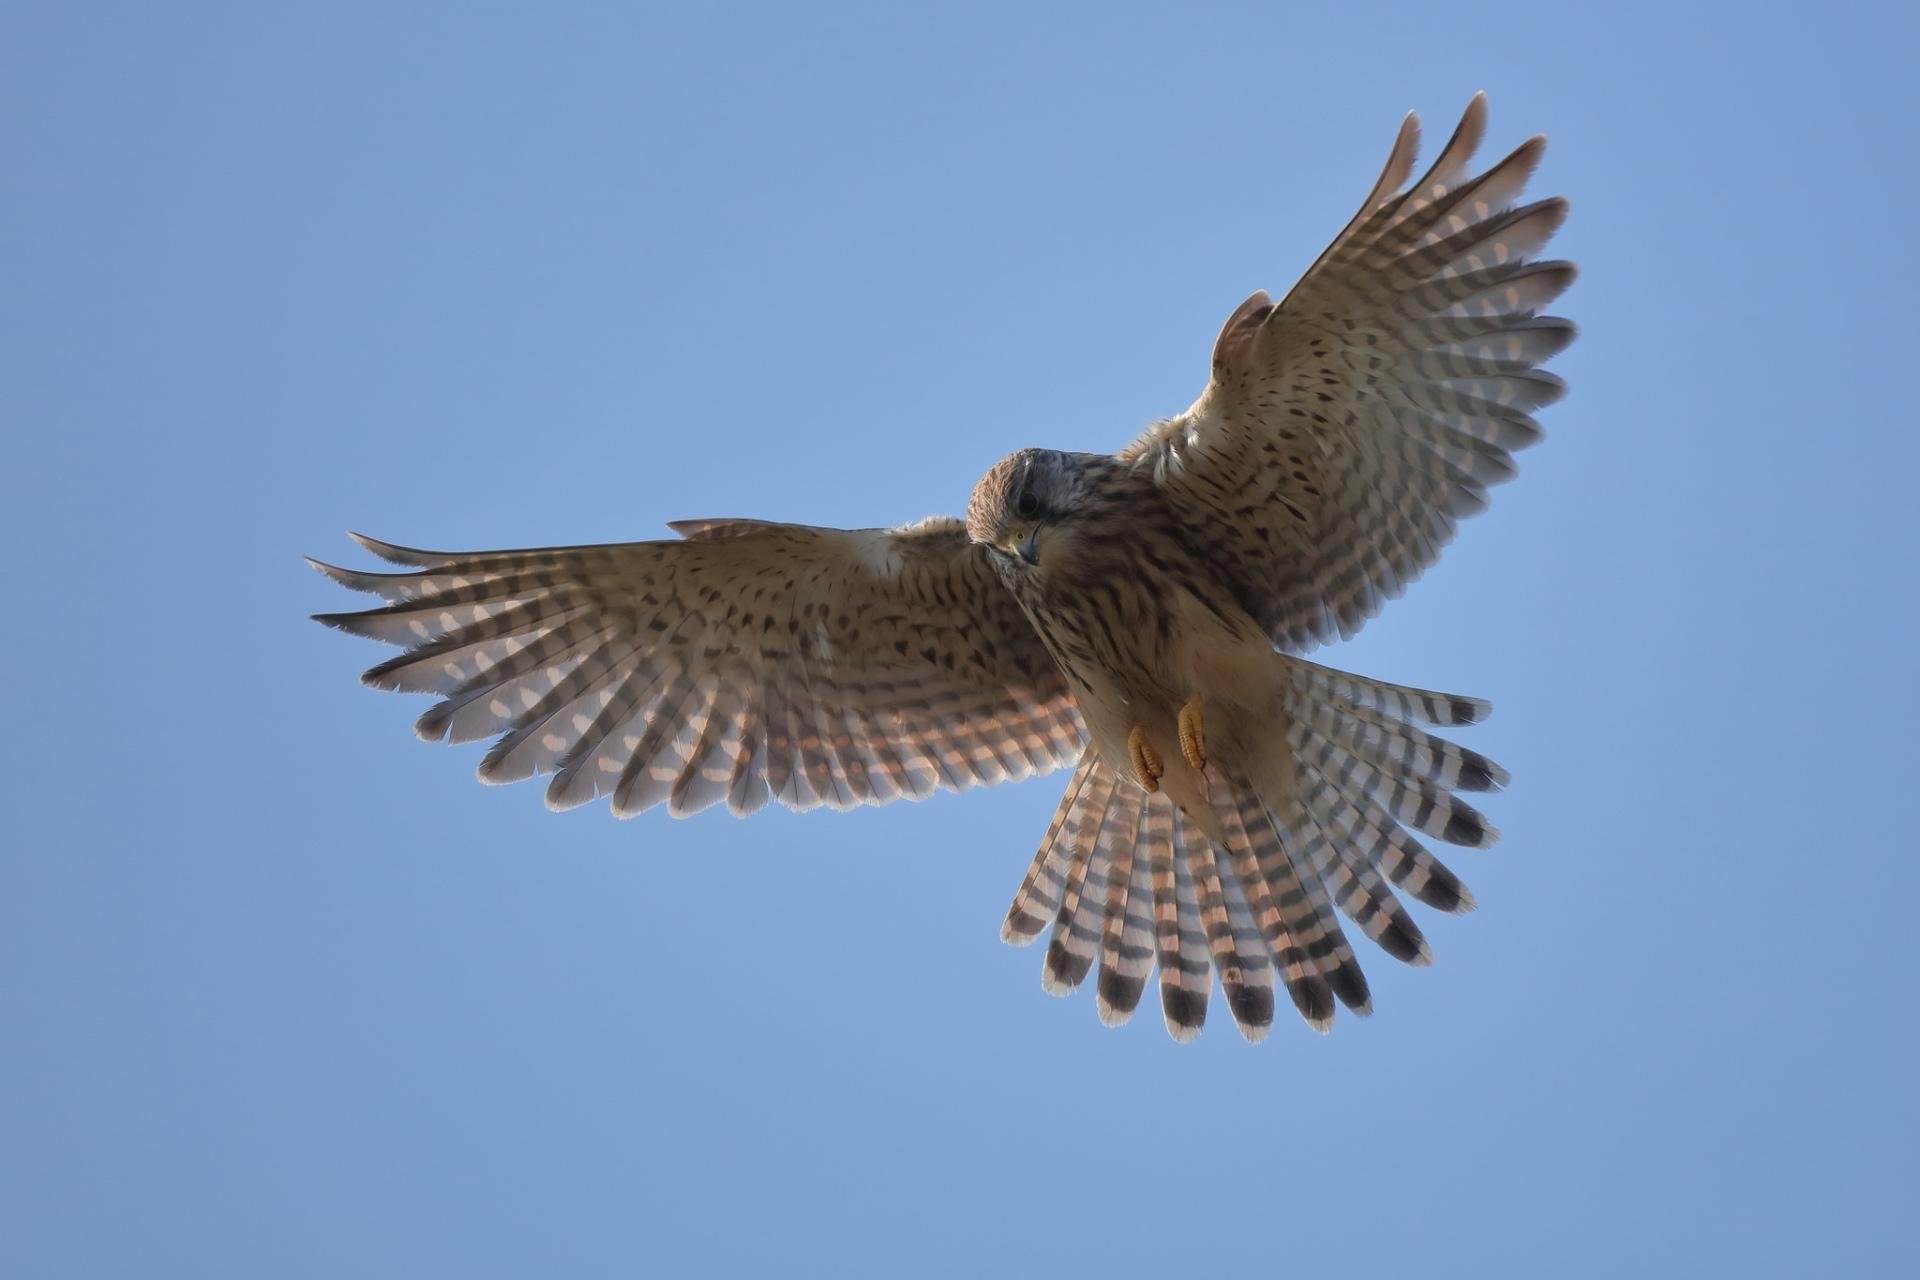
[1121,96,1574,651]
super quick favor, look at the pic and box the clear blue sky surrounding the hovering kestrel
[0,4,1920,1278]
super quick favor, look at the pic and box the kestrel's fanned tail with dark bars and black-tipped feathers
[1000,654,1507,1042]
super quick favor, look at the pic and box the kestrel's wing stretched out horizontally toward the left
[315,518,1085,816]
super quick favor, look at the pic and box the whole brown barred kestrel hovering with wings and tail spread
[315,96,1574,1040]
